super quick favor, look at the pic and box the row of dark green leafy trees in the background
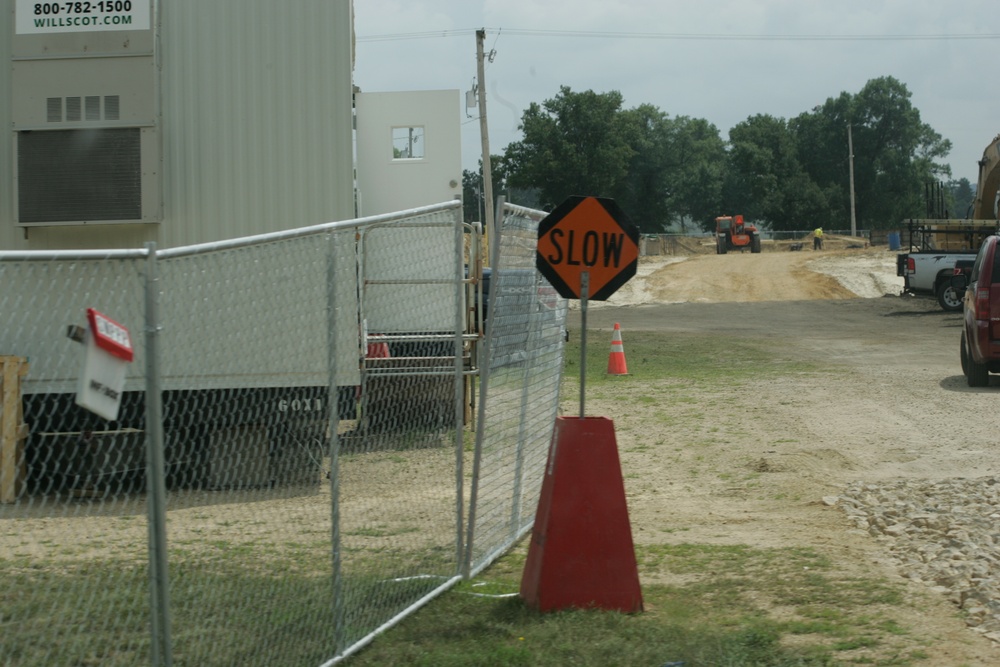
[463,77,973,234]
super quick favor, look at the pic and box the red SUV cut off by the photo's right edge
[952,236,1000,387]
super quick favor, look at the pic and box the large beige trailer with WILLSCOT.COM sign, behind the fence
[0,0,476,490]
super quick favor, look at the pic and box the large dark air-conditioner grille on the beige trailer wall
[17,129,142,223]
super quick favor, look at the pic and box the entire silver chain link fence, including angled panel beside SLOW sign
[0,202,565,667]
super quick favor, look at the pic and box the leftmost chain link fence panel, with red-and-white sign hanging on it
[0,252,150,667]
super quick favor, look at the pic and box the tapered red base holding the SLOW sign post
[521,417,642,612]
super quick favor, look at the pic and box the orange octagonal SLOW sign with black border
[535,196,639,301]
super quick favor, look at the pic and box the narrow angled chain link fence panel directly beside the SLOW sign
[467,204,567,573]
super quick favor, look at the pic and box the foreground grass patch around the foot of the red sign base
[350,544,920,667]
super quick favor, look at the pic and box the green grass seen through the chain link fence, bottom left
[0,544,454,667]
